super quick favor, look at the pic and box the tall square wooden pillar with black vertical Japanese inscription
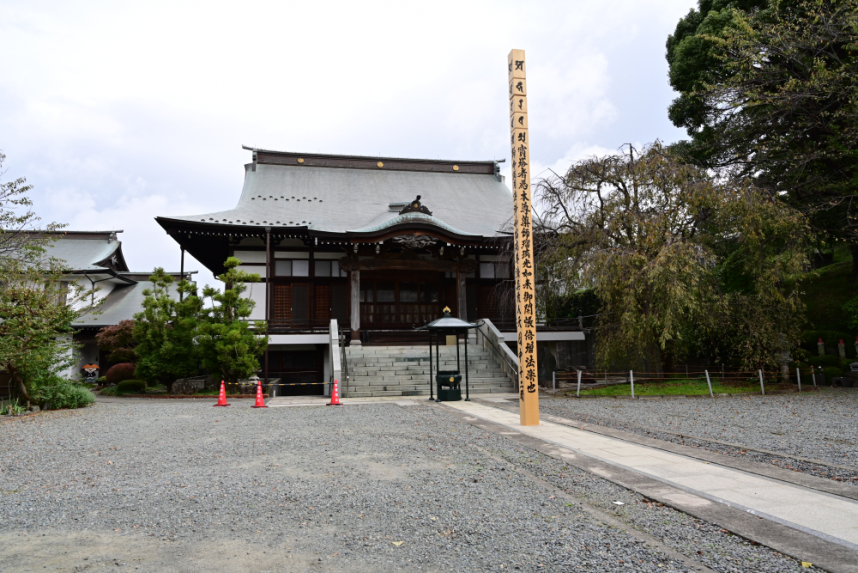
[508,50,539,426]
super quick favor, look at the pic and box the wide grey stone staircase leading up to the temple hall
[344,345,515,398]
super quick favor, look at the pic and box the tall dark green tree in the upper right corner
[667,0,858,277]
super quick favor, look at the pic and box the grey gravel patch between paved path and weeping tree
[539,390,858,485]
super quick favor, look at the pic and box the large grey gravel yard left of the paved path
[0,401,824,572]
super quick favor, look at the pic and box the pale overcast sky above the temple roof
[0,0,696,282]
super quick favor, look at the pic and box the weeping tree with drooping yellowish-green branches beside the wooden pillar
[535,143,807,371]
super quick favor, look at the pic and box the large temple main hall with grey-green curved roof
[157,147,583,396]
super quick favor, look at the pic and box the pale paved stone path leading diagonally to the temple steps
[444,401,858,549]
